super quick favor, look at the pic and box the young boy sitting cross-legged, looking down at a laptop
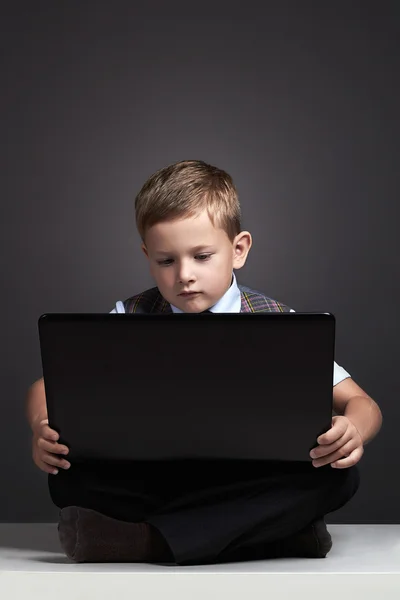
[27,161,382,564]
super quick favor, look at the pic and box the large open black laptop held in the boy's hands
[38,312,335,461]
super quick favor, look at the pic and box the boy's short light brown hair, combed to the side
[135,160,241,242]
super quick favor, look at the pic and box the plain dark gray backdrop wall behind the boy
[0,1,400,523]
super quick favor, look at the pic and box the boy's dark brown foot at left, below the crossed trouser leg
[58,506,174,562]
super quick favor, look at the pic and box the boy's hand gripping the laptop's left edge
[32,419,71,475]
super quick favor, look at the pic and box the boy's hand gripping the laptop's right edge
[310,415,364,469]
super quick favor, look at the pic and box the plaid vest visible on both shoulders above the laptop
[124,284,290,313]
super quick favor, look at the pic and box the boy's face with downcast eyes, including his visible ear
[142,210,252,313]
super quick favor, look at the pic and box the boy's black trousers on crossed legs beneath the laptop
[49,460,360,564]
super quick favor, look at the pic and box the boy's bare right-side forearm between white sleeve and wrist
[333,377,383,445]
